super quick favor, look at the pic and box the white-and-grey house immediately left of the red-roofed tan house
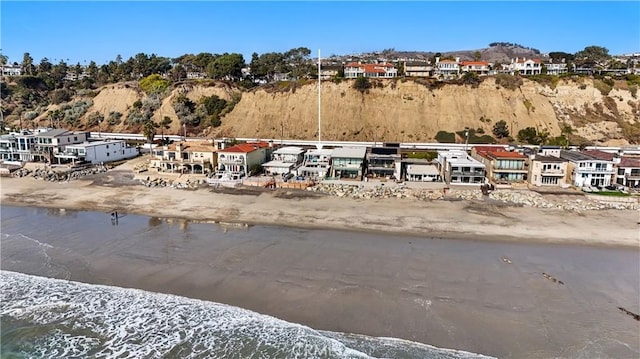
[436,150,486,185]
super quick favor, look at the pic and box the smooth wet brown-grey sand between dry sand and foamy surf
[1,205,640,358]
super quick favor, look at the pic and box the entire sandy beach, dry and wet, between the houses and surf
[0,159,640,358]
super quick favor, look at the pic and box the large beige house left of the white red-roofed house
[150,141,218,174]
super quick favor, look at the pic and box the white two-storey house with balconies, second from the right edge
[560,150,615,187]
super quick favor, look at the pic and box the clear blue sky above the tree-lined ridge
[0,0,640,64]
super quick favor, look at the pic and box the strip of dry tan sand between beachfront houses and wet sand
[0,168,640,248]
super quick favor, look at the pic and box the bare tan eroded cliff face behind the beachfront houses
[17,78,640,145]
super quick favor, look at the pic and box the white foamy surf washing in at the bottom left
[0,271,487,359]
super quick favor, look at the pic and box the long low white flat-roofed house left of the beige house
[54,140,139,164]
